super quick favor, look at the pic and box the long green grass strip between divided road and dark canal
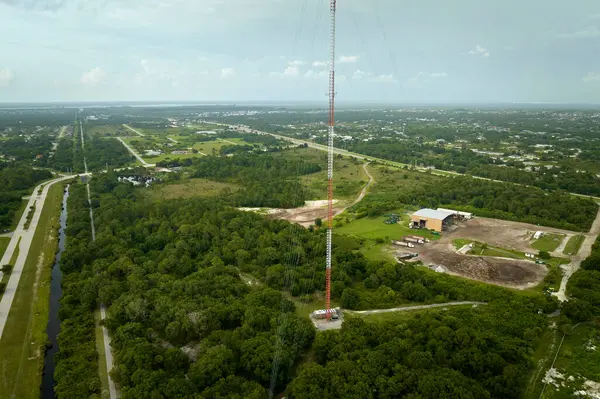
[0,184,63,398]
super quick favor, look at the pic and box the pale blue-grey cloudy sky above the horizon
[0,0,600,104]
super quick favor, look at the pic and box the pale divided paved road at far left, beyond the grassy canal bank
[0,175,75,338]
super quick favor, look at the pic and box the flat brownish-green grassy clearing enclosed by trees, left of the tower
[144,179,240,200]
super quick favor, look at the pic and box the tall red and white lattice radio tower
[325,0,336,320]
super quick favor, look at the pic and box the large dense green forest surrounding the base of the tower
[56,176,556,399]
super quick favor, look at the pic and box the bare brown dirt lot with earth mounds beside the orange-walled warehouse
[406,218,560,289]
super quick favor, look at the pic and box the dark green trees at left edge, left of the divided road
[0,162,52,229]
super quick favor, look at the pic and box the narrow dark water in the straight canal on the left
[40,185,69,399]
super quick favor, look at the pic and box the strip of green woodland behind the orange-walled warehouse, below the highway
[350,168,598,231]
